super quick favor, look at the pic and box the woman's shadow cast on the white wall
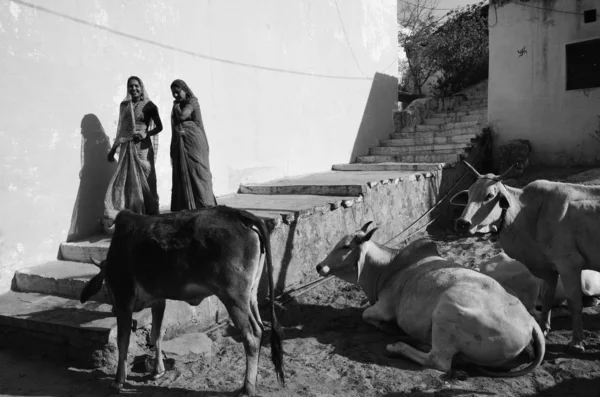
[67,114,117,241]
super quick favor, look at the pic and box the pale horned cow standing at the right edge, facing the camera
[451,162,600,353]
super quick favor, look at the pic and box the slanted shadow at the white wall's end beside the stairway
[349,73,398,163]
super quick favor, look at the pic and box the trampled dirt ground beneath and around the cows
[0,170,600,397]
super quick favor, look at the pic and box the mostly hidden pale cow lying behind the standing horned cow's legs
[479,252,600,322]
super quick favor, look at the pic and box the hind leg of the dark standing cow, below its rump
[225,298,262,397]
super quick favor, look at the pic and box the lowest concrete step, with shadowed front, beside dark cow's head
[0,291,151,366]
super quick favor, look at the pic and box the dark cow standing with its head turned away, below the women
[81,206,284,396]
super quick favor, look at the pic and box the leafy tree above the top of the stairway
[398,0,490,97]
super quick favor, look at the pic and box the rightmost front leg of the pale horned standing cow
[556,261,585,353]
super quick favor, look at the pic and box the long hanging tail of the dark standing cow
[251,219,285,385]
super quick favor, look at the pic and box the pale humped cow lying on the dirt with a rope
[317,222,546,377]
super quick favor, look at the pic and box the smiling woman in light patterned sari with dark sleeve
[104,76,162,233]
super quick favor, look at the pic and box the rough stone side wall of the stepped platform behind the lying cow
[260,170,442,297]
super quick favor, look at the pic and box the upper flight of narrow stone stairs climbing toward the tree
[333,80,487,171]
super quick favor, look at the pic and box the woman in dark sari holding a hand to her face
[171,80,217,211]
